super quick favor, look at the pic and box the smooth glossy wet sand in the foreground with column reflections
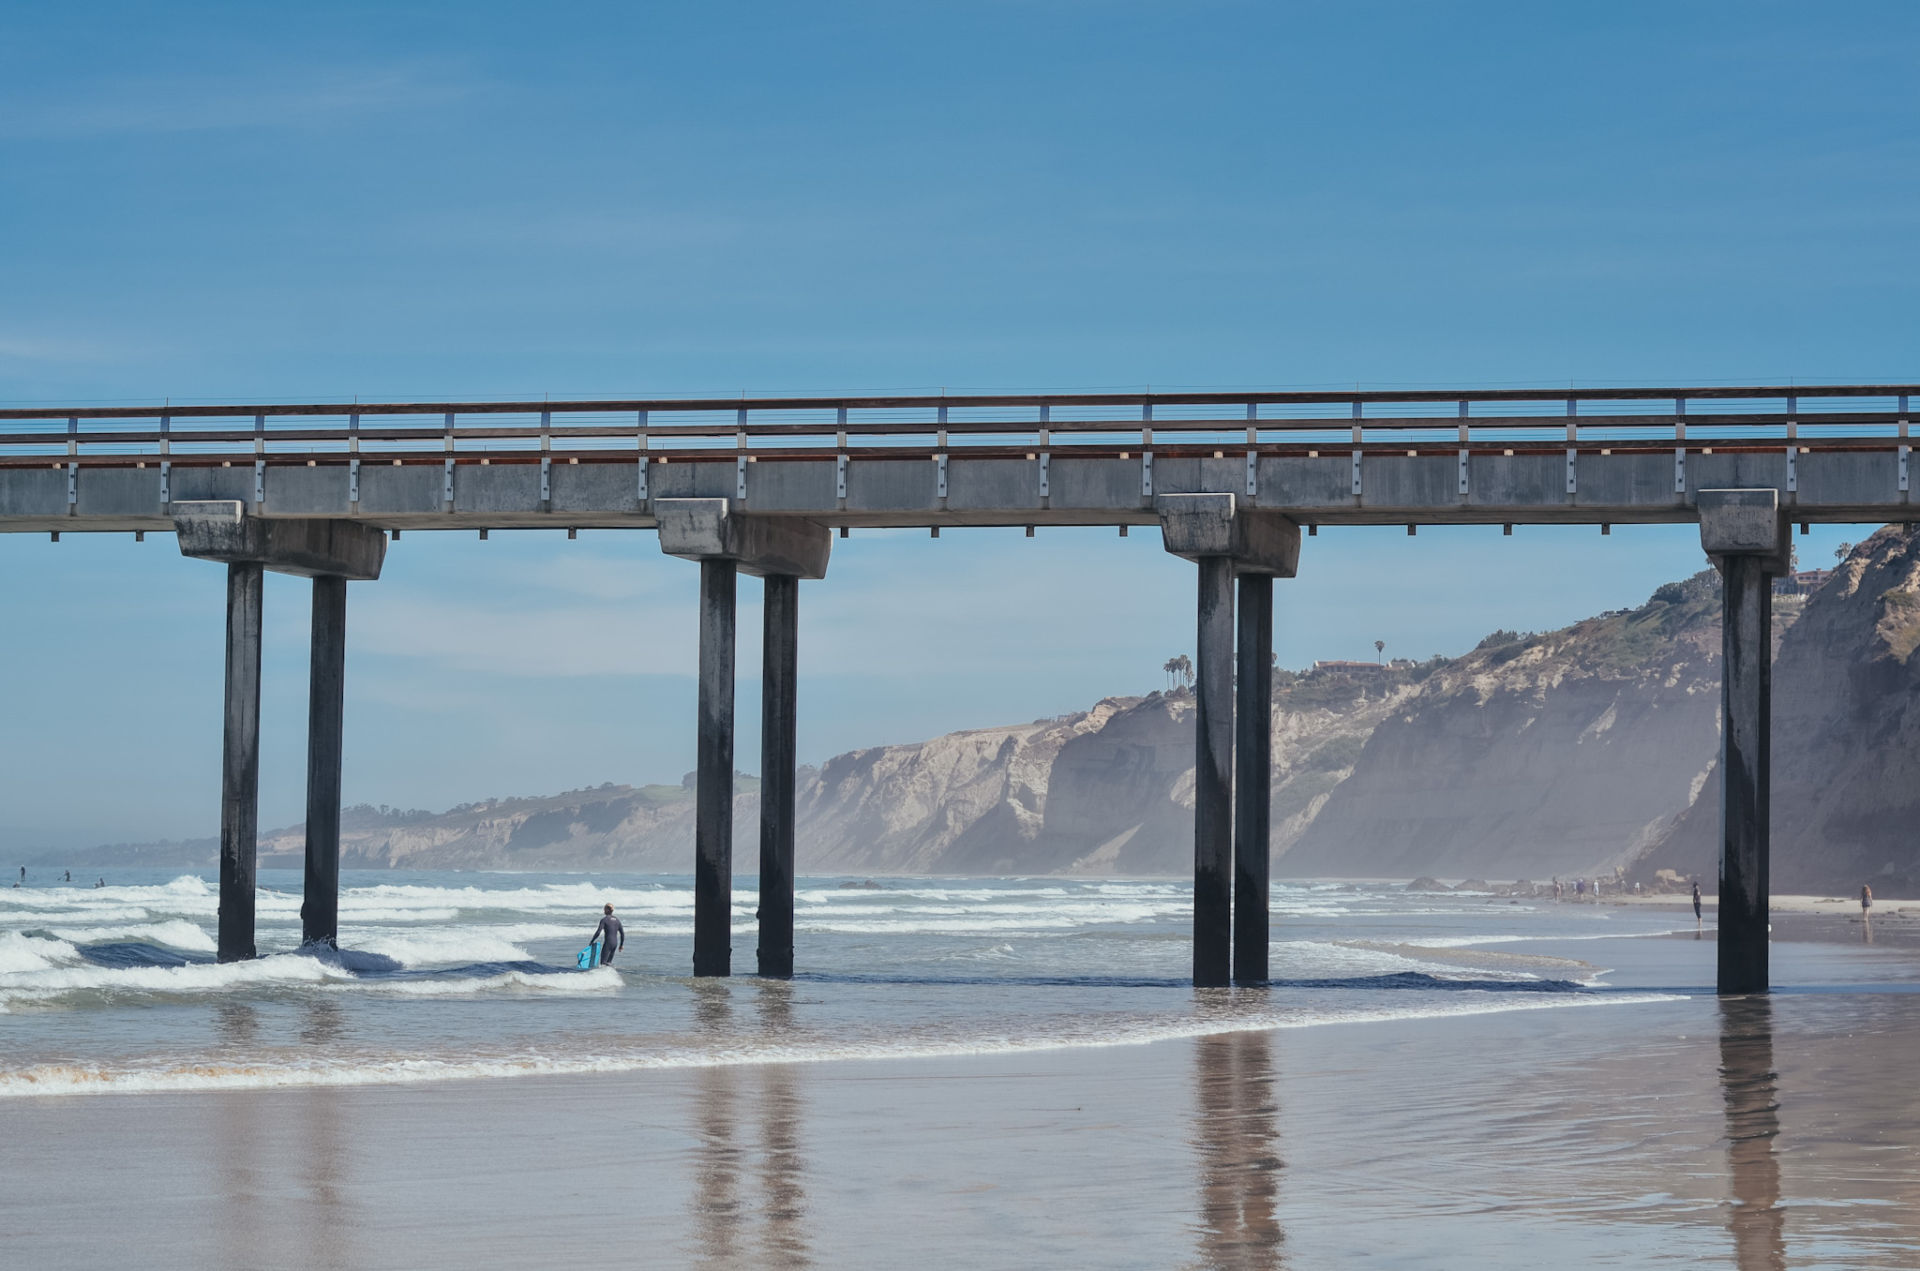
[0,971,1920,1271]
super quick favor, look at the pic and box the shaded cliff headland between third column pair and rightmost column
[1275,570,1743,877]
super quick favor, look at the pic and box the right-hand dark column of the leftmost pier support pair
[300,574,348,948]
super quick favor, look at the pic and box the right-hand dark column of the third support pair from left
[1233,574,1273,985]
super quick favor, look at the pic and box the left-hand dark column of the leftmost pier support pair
[217,563,265,962]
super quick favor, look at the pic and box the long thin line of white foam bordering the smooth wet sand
[0,998,1684,1098]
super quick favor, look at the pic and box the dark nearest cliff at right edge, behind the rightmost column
[1636,526,1920,895]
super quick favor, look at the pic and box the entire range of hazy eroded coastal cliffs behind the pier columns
[56,530,1920,895]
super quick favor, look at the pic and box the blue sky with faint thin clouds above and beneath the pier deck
[0,0,1920,854]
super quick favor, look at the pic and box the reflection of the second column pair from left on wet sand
[691,983,812,1269]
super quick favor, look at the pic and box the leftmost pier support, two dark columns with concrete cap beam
[173,501,386,962]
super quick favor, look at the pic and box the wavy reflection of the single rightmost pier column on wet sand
[1720,996,1788,1271]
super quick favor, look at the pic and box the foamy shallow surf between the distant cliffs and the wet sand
[0,872,1707,1096]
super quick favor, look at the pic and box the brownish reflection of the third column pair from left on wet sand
[1194,1031,1284,1269]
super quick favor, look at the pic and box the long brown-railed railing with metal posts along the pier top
[0,384,1920,468]
